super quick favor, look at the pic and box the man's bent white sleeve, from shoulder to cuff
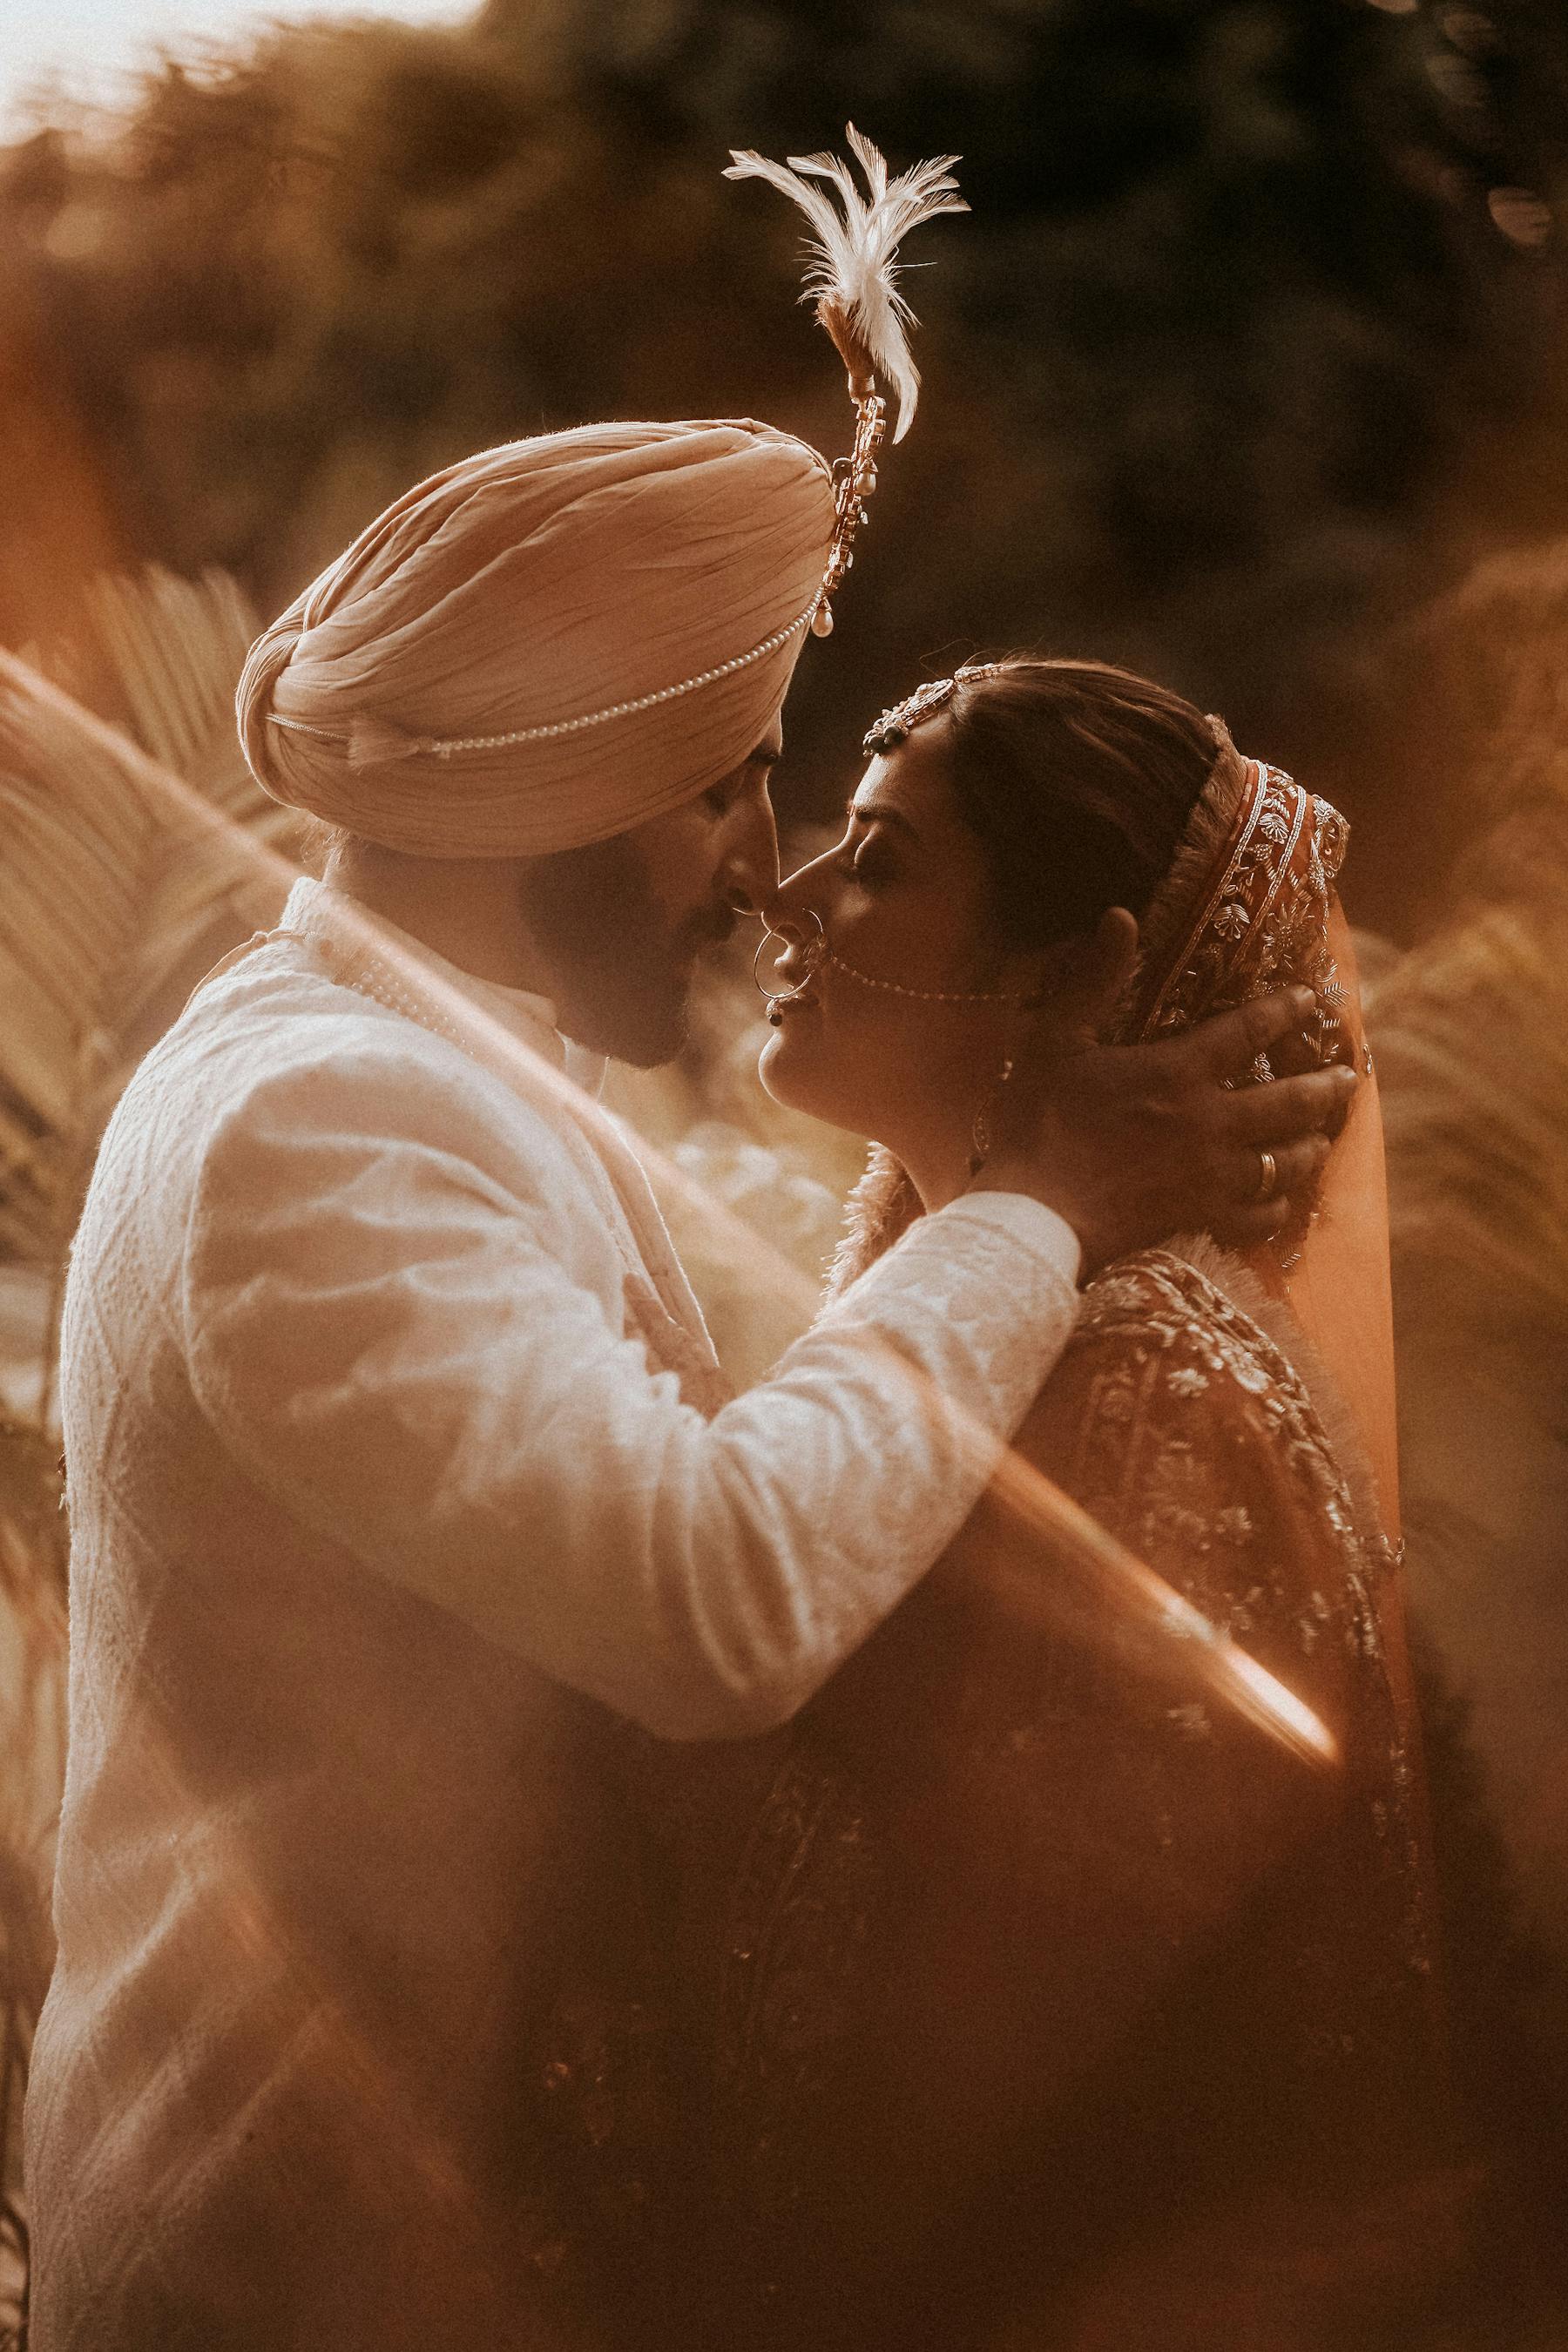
[183,1056,1077,1738]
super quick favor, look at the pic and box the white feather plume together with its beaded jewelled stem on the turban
[724,122,969,638]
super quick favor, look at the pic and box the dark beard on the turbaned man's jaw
[519,835,736,1071]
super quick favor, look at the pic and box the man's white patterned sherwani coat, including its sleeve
[28,884,1077,2352]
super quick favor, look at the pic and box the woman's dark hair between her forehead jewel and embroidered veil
[830,654,1236,1294]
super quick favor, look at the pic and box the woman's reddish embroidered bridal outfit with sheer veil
[557,755,1453,2352]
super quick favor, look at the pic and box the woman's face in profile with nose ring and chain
[760,718,1027,1150]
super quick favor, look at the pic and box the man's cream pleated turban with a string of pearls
[238,423,835,859]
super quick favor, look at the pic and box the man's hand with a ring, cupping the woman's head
[976,988,1356,1273]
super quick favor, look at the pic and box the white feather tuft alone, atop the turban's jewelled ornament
[724,122,969,440]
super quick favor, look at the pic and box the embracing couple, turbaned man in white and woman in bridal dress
[28,423,1436,2352]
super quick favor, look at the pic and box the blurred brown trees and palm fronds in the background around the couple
[0,0,1568,2352]
